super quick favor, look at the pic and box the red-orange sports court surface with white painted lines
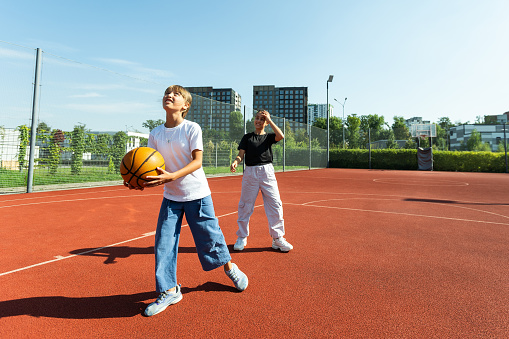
[0,169,509,338]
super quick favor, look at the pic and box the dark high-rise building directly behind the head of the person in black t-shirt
[253,85,308,124]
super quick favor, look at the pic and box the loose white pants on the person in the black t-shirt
[237,164,285,238]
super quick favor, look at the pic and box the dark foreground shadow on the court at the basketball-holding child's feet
[0,281,232,319]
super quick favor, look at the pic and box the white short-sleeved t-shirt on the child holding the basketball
[148,120,211,201]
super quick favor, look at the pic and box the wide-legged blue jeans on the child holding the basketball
[154,195,231,292]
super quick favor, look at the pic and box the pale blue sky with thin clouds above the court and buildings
[0,0,509,130]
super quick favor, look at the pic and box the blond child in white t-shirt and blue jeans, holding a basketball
[125,85,248,316]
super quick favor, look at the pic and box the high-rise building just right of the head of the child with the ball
[186,86,242,131]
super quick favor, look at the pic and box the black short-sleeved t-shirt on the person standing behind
[238,132,277,166]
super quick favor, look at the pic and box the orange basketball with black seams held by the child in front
[120,147,164,187]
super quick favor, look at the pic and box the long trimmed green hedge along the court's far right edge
[329,149,506,173]
